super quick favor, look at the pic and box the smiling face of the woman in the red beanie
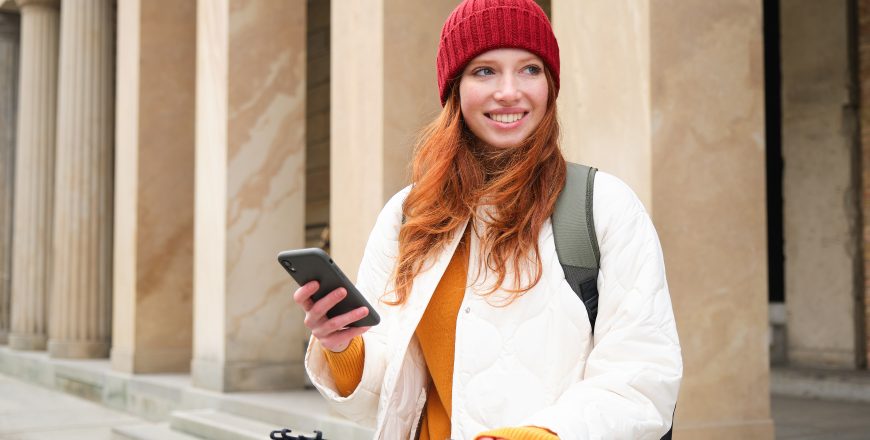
[459,49,547,148]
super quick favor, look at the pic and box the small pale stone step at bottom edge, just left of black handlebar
[170,409,290,440]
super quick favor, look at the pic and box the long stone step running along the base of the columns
[0,346,374,440]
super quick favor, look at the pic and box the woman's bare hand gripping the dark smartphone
[293,281,371,352]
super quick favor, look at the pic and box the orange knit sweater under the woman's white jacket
[324,237,559,440]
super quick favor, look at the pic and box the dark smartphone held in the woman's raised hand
[278,248,381,327]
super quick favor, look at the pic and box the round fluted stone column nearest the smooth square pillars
[48,0,115,358]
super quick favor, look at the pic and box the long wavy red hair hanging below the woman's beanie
[386,69,565,305]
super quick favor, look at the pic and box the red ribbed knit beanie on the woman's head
[437,0,559,106]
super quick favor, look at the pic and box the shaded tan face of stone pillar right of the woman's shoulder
[650,0,773,438]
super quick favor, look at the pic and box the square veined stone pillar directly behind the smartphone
[191,0,307,391]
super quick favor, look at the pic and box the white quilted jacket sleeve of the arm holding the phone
[305,187,410,427]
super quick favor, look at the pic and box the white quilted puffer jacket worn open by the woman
[306,172,682,440]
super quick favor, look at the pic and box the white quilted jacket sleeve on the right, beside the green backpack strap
[523,172,683,440]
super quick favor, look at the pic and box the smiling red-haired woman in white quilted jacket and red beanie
[294,0,682,440]
